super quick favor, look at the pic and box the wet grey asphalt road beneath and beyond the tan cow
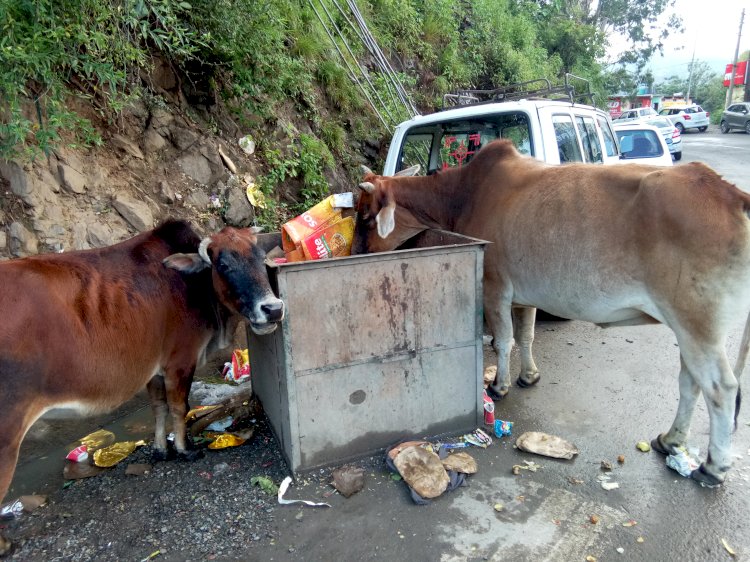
[7,130,750,562]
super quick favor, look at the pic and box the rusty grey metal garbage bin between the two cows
[248,230,486,472]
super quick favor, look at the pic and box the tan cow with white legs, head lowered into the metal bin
[354,140,750,485]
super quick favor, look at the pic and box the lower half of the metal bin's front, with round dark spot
[297,347,478,467]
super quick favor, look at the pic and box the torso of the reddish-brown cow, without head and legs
[0,223,210,412]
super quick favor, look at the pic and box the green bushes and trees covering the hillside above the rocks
[0,0,680,227]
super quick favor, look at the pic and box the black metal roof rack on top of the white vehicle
[442,73,594,110]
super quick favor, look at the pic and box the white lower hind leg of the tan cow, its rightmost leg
[683,346,739,486]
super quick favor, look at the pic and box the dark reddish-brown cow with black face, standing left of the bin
[0,221,284,553]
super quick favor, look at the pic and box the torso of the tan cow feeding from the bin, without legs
[457,152,750,323]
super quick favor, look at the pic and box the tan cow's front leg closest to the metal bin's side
[484,279,513,400]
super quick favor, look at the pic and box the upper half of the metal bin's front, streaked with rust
[286,250,476,374]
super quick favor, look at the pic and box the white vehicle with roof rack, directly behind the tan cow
[383,77,620,175]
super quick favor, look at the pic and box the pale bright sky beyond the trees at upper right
[610,0,750,82]
